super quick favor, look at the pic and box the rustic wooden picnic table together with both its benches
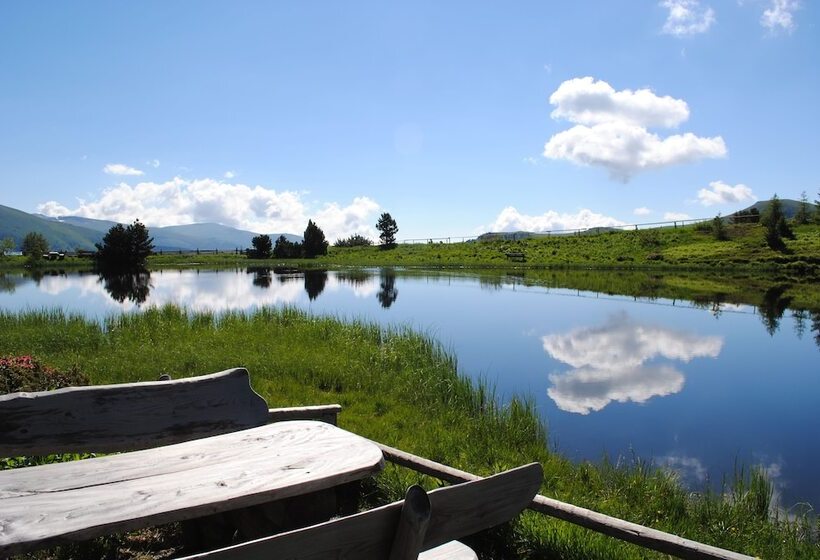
[0,368,541,560]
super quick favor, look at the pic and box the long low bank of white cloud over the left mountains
[37,177,379,240]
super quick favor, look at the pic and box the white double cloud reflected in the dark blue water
[542,313,723,414]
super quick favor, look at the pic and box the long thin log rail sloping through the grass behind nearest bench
[376,443,753,560]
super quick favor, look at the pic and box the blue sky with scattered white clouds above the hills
[0,0,820,241]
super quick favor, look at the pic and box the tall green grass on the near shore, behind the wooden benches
[0,307,820,559]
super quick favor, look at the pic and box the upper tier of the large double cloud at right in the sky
[550,76,689,128]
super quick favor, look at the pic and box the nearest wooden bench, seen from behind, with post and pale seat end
[175,463,543,560]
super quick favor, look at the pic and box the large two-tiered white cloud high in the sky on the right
[544,77,726,182]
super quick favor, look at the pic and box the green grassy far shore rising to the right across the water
[0,222,820,278]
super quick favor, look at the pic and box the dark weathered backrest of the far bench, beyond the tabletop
[0,368,268,457]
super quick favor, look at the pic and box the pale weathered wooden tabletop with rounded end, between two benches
[0,421,384,557]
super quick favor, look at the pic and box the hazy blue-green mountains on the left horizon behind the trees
[0,206,302,251]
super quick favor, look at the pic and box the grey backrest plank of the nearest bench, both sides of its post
[178,463,543,560]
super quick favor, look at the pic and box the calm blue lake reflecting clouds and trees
[0,268,820,509]
